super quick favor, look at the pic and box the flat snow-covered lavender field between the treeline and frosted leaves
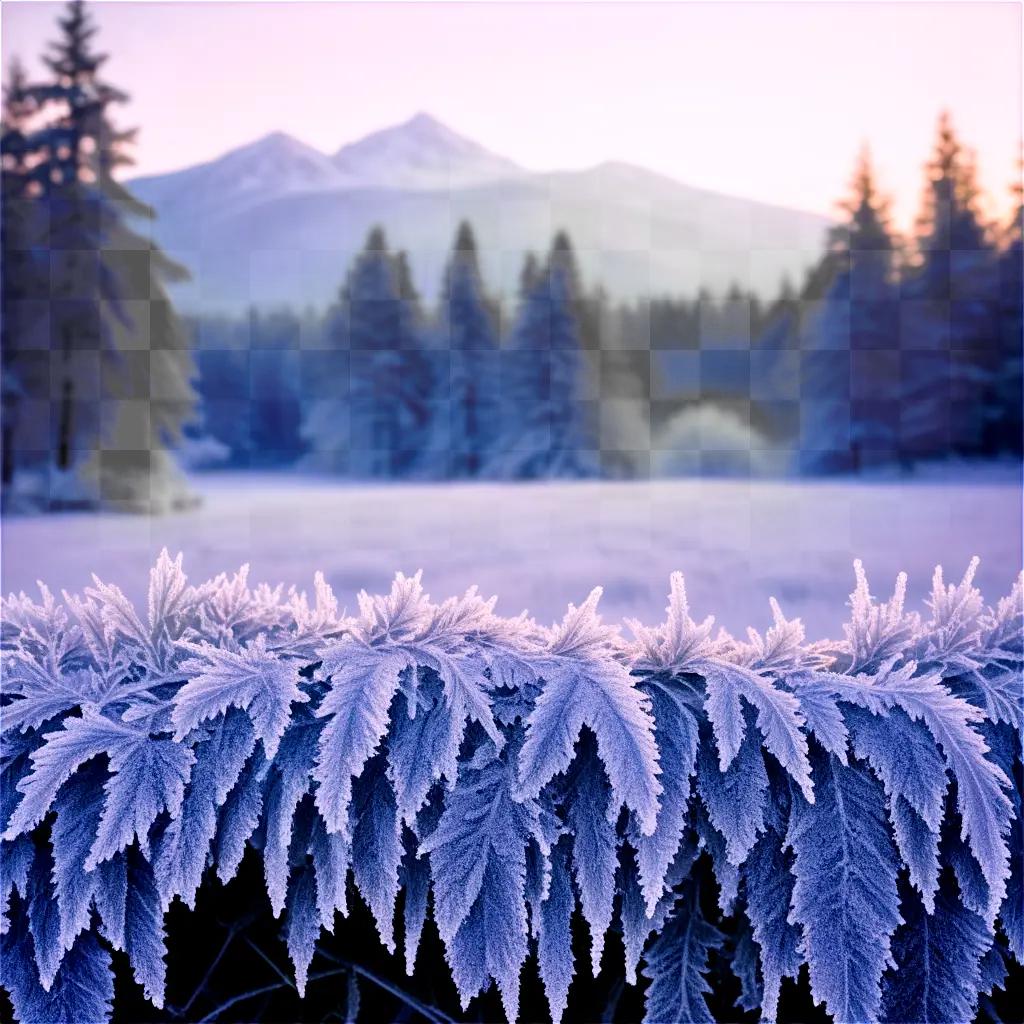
[0,469,1021,638]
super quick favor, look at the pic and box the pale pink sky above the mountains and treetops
[2,0,1022,226]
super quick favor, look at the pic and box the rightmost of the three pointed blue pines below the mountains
[496,231,599,478]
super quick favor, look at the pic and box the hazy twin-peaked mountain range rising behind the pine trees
[128,114,830,312]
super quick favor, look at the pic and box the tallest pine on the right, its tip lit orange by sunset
[900,113,998,459]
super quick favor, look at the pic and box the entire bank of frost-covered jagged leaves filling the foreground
[0,553,1024,1024]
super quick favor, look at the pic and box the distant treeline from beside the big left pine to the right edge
[190,116,1022,478]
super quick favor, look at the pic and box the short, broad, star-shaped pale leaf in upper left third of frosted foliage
[171,634,309,758]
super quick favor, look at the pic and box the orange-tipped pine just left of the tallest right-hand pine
[798,148,899,472]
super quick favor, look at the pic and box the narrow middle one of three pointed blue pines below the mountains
[437,221,500,477]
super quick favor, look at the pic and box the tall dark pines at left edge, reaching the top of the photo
[2,0,195,511]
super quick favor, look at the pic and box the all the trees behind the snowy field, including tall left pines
[0,2,1022,510]
